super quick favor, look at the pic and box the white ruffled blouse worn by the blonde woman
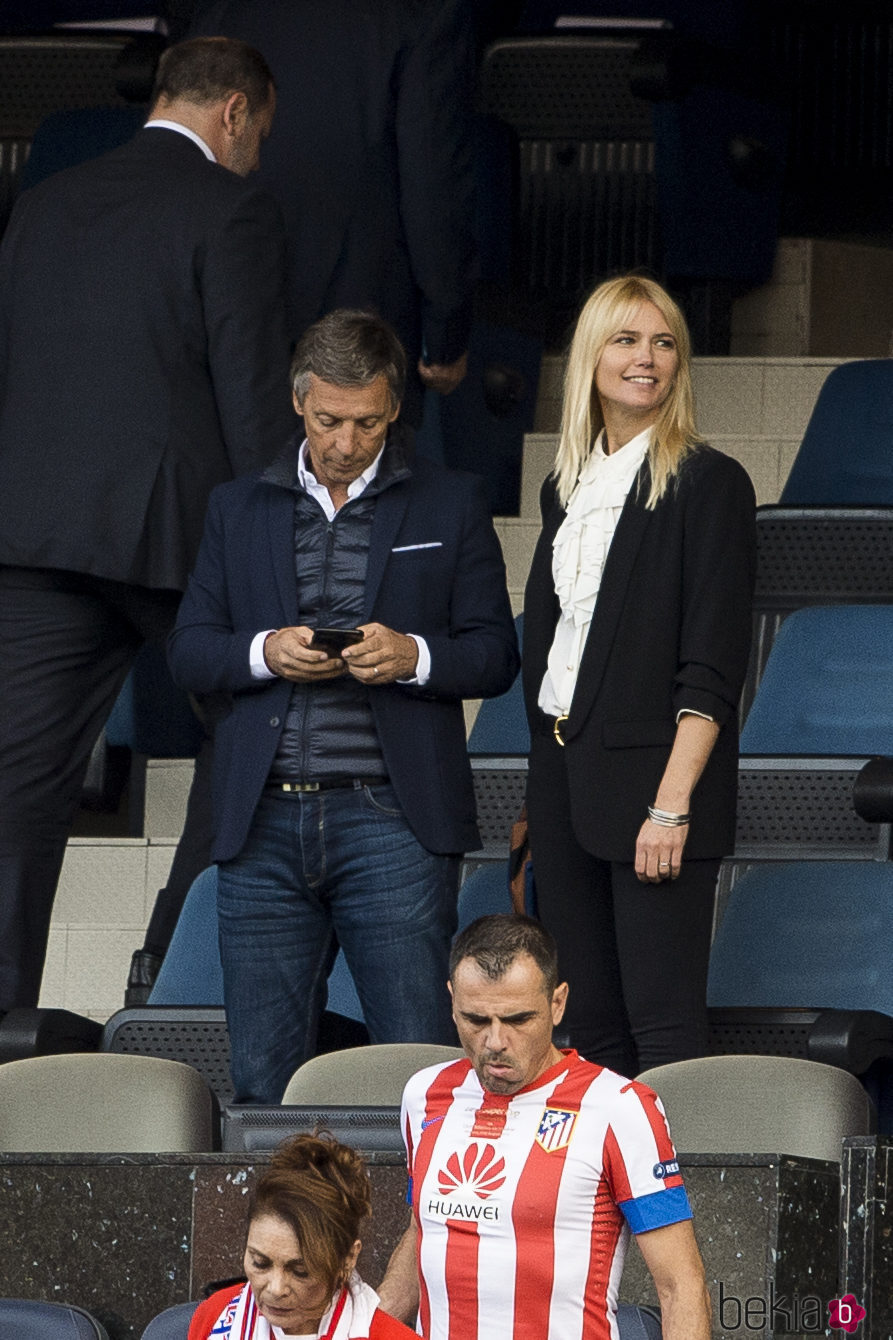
[539,427,652,717]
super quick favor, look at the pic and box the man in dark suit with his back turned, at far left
[0,39,291,1012]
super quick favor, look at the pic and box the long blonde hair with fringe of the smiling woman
[552,275,700,508]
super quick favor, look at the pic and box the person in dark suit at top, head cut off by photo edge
[192,0,475,423]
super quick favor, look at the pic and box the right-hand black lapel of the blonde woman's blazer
[563,461,652,740]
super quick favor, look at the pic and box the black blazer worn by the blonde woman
[523,446,756,862]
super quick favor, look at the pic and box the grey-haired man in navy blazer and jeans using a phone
[169,310,518,1103]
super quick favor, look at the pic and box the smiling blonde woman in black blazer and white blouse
[523,276,755,1075]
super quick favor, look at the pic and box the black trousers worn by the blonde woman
[527,734,720,1075]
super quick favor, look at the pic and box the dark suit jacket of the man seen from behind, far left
[0,129,294,590]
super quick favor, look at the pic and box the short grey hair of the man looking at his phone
[291,308,406,409]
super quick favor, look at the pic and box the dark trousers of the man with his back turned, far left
[0,567,208,1012]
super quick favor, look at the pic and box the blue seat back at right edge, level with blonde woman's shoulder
[780,358,893,505]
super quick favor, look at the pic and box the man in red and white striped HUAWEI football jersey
[381,915,711,1340]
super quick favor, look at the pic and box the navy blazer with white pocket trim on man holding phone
[169,436,518,860]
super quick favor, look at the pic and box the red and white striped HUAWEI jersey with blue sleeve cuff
[402,1051,692,1340]
